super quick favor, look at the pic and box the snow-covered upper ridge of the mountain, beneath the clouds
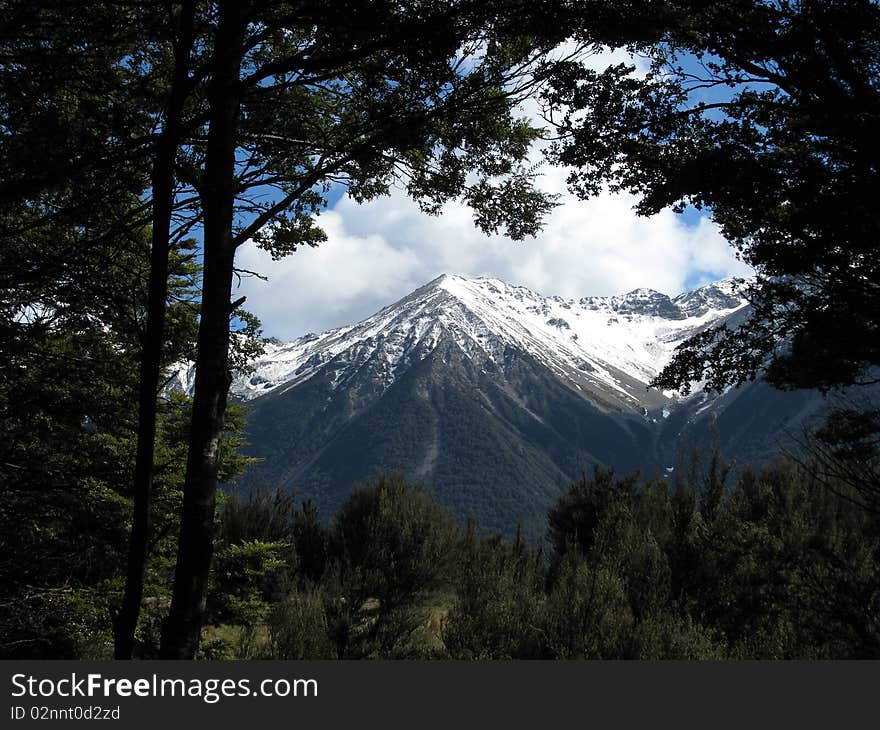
[172,275,747,409]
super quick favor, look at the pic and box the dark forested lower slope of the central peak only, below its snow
[241,341,650,533]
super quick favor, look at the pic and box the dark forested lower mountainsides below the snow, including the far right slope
[240,353,840,538]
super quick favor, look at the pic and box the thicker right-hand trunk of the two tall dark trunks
[160,0,245,659]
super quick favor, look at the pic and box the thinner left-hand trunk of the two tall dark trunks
[113,2,195,659]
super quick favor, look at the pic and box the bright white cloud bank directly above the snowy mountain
[236,49,749,339]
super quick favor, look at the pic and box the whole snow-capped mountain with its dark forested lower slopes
[187,276,817,536]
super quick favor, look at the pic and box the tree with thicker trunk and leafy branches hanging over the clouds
[157,0,584,657]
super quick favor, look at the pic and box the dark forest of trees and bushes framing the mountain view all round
[0,0,880,659]
